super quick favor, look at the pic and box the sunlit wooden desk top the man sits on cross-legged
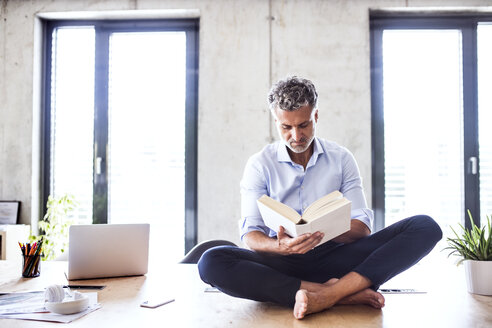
[0,254,492,328]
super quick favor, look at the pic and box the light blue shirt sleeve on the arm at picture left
[239,157,275,240]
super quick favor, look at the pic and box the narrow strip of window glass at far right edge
[477,24,492,223]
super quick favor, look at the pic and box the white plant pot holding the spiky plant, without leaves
[463,260,492,295]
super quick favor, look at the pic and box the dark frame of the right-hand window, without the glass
[369,10,492,231]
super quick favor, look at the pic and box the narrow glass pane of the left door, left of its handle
[50,27,95,224]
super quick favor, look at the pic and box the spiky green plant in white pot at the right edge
[445,210,492,295]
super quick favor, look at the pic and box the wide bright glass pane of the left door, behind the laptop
[108,32,186,262]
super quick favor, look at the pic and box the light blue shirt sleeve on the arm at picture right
[340,150,374,231]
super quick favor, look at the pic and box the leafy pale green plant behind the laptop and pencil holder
[30,195,77,261]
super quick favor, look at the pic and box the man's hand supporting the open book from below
[277,226,324,255]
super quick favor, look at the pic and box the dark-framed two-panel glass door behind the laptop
[43,20,198,263]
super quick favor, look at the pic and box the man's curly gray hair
[268,76,318,115]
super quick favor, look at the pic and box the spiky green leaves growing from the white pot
[445,210,492,265]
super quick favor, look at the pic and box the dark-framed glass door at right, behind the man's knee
[371,13,492,233]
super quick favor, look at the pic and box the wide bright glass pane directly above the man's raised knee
[383,30,464,231]
